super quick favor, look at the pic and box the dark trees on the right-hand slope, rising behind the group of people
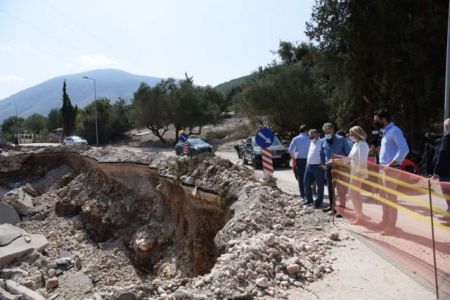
[225,0,448,145]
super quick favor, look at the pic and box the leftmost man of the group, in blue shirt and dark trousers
[288,125,310,199]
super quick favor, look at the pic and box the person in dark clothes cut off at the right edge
[433,118,450,211]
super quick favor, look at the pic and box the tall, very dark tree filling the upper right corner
[306,0,448,144]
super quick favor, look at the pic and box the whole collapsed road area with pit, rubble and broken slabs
[0,147,339,299]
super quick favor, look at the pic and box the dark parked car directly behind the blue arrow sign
[241,135,290,169]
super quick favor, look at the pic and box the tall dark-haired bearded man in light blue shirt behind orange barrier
[373,109,409,235]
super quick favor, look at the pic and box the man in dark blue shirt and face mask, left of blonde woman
[322,123,351,212]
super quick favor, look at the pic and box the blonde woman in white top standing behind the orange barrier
[348,126,369,224]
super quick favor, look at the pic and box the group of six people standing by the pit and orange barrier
[289,110,450,233]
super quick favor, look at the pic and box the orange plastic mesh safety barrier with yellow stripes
[332,157,450,298]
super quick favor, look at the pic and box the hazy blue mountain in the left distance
[0,69,162,123]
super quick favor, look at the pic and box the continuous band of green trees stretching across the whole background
[1,0,448,147]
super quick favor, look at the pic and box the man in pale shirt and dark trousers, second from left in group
[304,129,325,208]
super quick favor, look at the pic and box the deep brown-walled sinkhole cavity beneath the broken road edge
[0,153,227,277]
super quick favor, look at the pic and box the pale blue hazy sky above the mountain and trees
[0,0,315,99]
